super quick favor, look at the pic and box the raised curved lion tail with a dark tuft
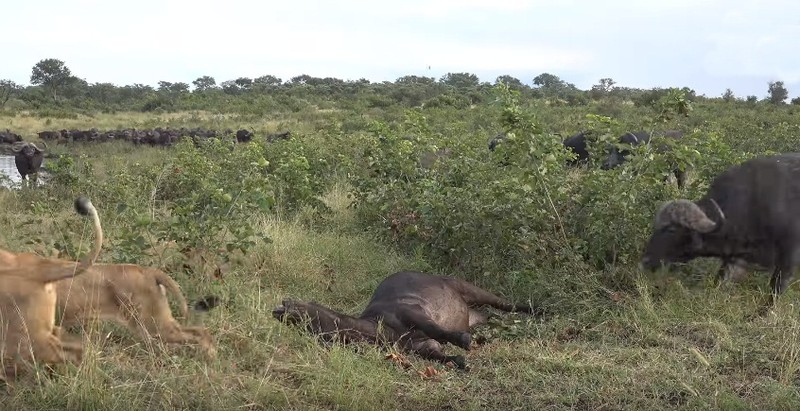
[31,197,103,283]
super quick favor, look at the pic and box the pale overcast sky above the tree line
[0,0,800,98]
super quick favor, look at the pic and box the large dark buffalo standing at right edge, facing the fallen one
[641,153,800,303]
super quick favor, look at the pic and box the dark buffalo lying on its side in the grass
[272,271,534,368]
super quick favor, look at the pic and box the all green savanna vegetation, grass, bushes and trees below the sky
[0,62,800,410]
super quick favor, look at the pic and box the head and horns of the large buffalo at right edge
[641,199,725,271]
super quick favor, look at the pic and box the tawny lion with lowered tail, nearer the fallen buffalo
[56,264,216,358]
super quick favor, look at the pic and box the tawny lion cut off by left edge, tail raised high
[0,197,103,376]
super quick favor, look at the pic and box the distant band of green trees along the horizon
[0,58,800,111]
